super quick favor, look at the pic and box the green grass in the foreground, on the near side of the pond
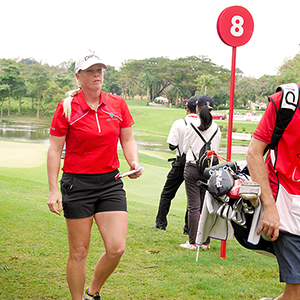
[0,143,283,300]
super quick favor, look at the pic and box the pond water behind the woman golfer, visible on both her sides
[0,118,169,152]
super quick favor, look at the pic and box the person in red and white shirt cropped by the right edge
[247,84,300,300]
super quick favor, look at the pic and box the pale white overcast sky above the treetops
[0,0,300,77]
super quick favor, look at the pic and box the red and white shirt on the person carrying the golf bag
[253,88,300,236]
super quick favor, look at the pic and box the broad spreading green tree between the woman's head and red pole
[120,56,230,106]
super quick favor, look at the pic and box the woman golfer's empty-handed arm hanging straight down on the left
[47,135,66,215]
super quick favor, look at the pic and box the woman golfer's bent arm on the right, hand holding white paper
[120,127,143,178]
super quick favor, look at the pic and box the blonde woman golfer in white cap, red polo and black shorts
[47,53,142,300]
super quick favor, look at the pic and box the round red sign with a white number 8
[217,6,254,47]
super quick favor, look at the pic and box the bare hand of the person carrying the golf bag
[257,202,280,242]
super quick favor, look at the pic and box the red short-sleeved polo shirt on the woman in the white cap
[50,91,134,174]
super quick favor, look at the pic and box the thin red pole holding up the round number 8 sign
[220,47,236,258]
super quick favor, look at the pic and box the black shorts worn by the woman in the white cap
[60,170,127,219]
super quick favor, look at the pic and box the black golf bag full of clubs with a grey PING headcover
[197,162,275,257]
